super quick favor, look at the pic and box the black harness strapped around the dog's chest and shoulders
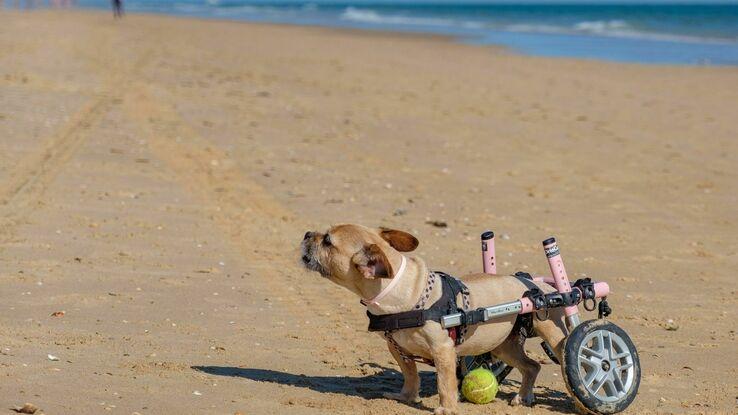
[366,271,469,342]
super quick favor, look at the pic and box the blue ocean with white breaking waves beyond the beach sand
[72,0,738,65]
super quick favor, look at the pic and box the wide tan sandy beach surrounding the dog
[0,11,738,415]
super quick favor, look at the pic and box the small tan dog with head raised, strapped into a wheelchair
[302,225,565,415]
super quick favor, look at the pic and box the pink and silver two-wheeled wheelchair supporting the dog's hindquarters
[448,231,641,414]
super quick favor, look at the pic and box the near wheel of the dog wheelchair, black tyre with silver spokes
[562,320,641,414]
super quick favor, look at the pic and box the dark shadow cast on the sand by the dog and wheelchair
[197,363,574,413]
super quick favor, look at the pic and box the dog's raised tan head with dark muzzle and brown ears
[301,225,418,289]
